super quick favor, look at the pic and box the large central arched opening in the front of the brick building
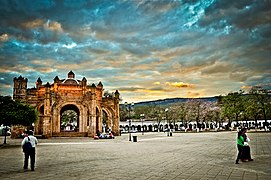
[60,105,80,132]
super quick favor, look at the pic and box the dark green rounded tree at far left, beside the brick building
[0,96,38,144]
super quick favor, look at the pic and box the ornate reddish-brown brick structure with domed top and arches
[13,71,120,138]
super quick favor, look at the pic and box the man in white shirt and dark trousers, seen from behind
[22,130,38,171]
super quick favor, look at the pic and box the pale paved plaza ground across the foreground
[0,132,271,180]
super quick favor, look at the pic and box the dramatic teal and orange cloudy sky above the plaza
[0,0,271,102]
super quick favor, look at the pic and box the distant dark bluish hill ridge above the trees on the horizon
[121,97,220,106]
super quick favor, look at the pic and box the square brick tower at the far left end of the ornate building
[13,76,28,100]
